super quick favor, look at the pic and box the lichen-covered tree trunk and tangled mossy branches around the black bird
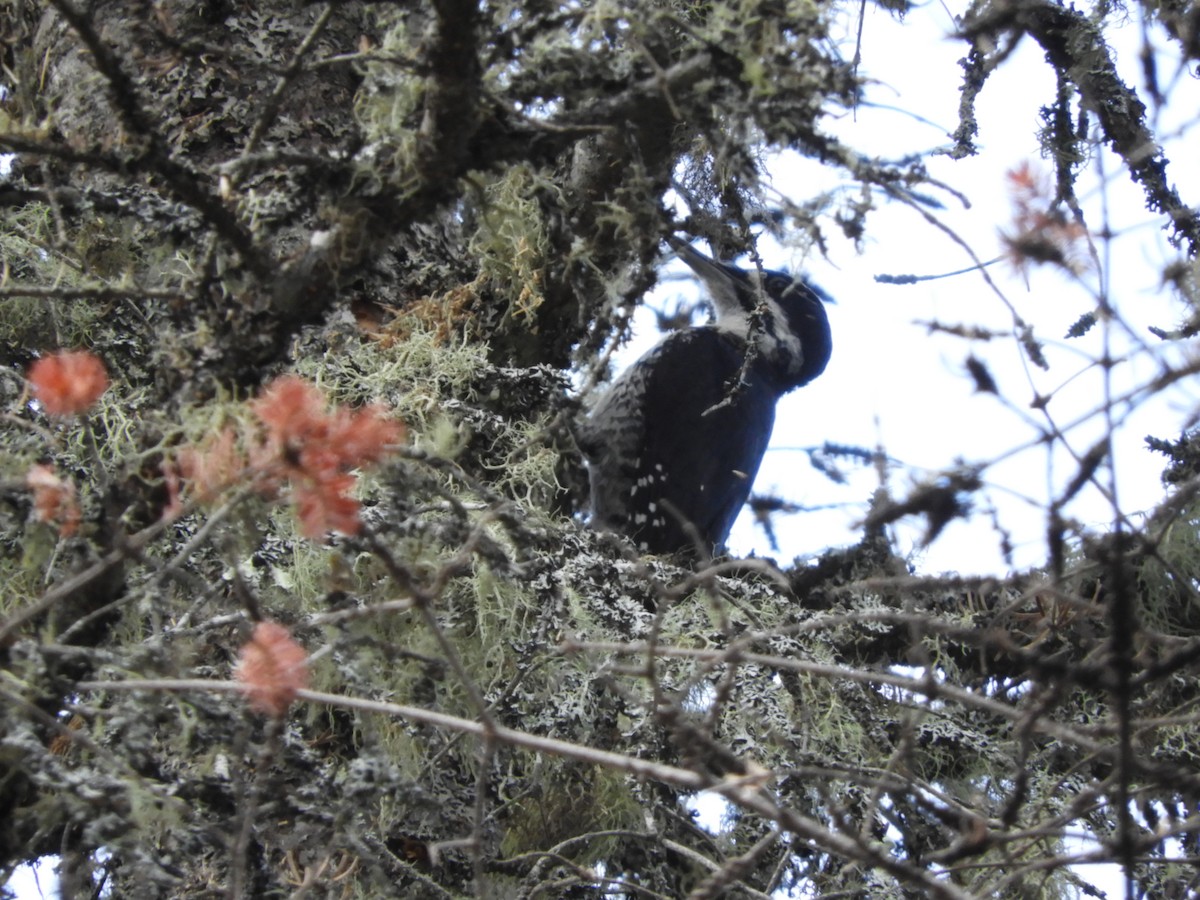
[0,0,1200,898]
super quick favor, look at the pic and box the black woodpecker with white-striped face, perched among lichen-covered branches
[578,239,832,553]
